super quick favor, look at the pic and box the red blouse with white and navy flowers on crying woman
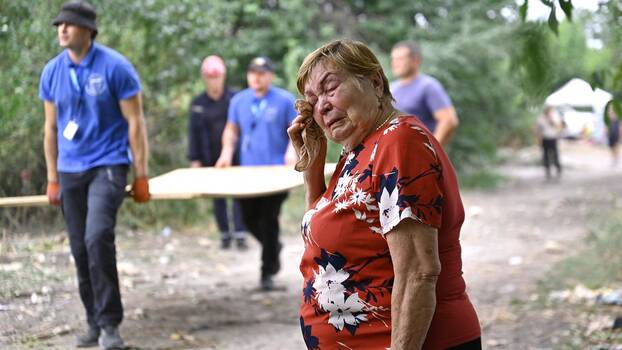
[300,117,480,350]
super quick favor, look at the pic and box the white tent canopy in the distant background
[545,78,612,112]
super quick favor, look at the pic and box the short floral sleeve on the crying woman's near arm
[372,119,443,234]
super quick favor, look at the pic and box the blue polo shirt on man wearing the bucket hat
[39,42,141,172]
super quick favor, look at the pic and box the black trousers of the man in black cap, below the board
[240,193,287,276]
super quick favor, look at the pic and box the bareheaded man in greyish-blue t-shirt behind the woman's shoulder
[390,41,458,146]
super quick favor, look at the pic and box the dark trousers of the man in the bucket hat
[59,165,128,327]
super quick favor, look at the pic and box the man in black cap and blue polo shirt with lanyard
[216,57,297,290]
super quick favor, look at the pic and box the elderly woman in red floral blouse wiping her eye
[288,40,481,350]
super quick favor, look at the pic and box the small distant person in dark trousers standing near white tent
[536,105,564,180]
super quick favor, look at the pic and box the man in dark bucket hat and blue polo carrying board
[39,1,149,349]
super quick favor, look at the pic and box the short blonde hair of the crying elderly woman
[296,39,393,101]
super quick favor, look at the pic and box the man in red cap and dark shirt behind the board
[188,55,247,249]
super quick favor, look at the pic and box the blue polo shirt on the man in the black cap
[228,87,297,165]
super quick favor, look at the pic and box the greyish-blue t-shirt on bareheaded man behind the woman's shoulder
[390,73,452,132]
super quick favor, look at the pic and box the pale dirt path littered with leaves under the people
[0,139,622,350]
